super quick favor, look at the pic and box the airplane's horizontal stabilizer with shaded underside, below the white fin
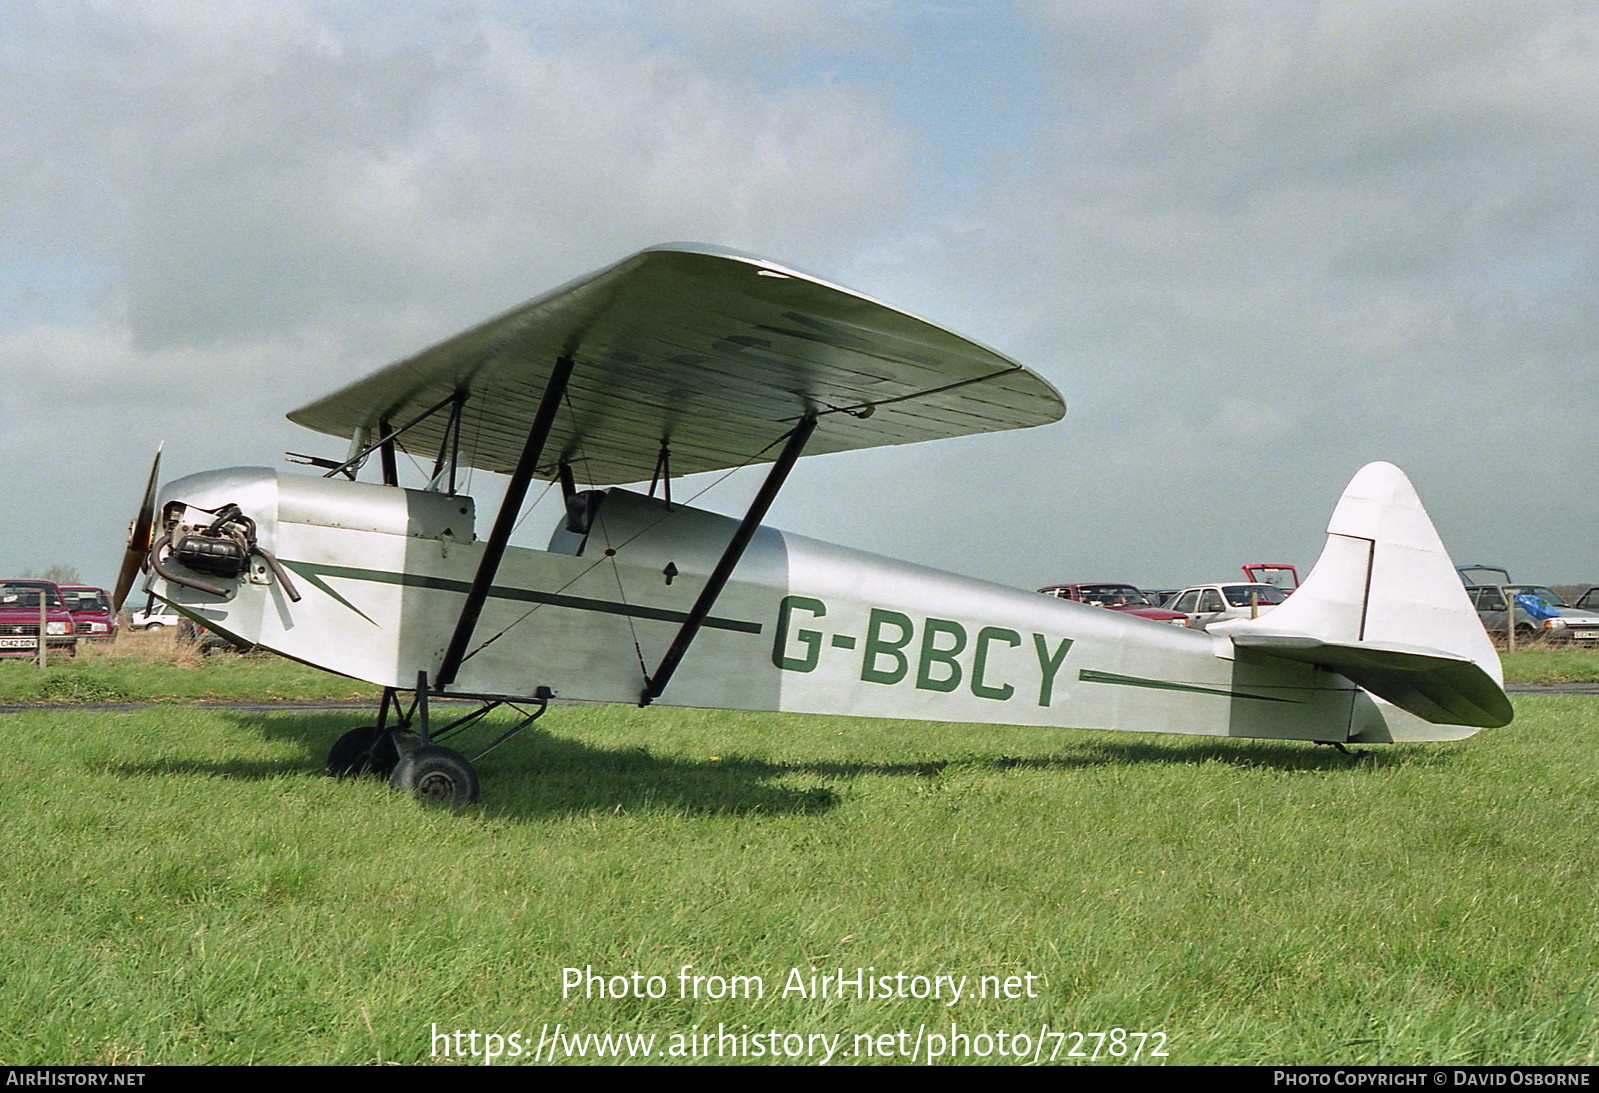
[1233,633,1514,729]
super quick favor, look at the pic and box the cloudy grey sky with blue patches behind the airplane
[0,0,1599,588]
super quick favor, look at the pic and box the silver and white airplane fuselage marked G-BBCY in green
[150,468,1451,741]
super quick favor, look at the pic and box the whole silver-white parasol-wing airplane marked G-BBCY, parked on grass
[118,246,1511,801]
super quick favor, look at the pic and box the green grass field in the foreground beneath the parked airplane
[0,635,1599,1064]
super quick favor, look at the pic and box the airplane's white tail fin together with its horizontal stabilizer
[1214,463,1513,735]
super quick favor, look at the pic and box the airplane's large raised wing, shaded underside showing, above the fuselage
[289,244,1065,483]
